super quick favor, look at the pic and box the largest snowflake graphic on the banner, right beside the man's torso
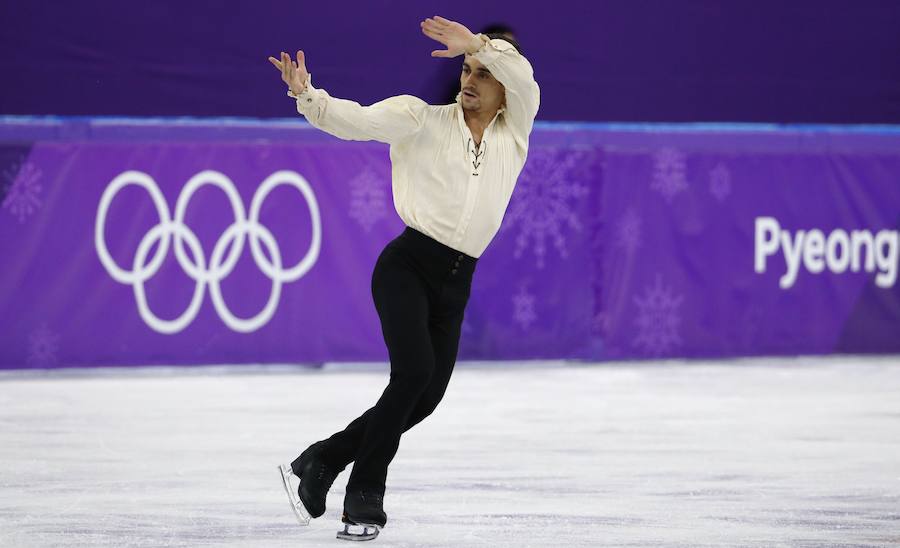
[500,148,593,269]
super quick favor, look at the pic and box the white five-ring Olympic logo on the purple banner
[95,170,322,334]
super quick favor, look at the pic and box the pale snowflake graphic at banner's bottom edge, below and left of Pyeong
[632,275,684,356]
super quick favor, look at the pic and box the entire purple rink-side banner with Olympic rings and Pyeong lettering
[0,118,900,368]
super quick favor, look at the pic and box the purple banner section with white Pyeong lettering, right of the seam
[594,129,900,358]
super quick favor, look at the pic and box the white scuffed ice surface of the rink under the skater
[0,357,900,548]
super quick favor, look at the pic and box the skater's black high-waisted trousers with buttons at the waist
[323,226,477,495]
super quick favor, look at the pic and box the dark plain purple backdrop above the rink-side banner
[0,0,900,123]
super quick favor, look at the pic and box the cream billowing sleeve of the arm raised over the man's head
[472,34,541,148]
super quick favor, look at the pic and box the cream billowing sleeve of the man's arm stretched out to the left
[288,75,428,144]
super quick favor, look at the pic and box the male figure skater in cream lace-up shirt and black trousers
[269,17,540,540]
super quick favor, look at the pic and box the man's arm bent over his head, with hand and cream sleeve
[421,16,541,148]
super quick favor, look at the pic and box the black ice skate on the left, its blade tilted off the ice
[279,442,343,525]
